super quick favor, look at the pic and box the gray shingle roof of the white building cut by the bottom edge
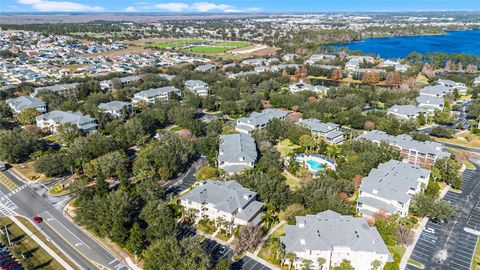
[280,210,390,254]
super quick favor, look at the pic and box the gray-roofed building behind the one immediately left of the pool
[235,109,290,134]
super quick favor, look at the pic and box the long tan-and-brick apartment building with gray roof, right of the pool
[357,130,450,168]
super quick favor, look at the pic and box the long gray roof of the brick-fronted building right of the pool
[357,130,450,158]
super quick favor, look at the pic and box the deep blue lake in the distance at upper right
[334,30,480,58]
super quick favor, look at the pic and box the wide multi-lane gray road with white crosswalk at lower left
[0,171,129,269]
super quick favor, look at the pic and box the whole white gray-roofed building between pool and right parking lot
[356,160,431,217]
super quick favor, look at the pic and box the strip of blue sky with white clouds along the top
[0,0,480,13]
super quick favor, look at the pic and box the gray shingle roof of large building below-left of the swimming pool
[183,180,257,214]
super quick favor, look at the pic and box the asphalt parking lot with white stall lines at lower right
[406,170,480,270]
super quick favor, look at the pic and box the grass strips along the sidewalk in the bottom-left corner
[0,217,77,269]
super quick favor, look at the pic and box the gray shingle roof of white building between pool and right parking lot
[358,160,430,205]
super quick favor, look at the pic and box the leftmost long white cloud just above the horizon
[18,0,104,12]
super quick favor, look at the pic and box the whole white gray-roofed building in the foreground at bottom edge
[280,210,393,270]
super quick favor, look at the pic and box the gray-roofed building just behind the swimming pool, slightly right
[297,118,345,144]
